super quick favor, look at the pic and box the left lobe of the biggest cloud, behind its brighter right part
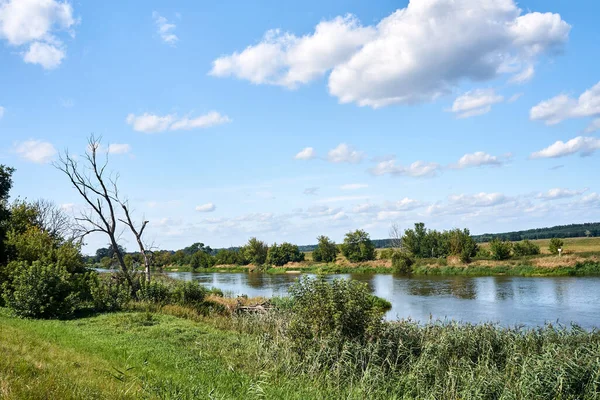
[210,15,374,88]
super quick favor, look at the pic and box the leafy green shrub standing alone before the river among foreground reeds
[288,277,383,350]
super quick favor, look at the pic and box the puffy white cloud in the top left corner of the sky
[0,0,77,69]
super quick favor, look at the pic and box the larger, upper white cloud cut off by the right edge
[529,82,600,125]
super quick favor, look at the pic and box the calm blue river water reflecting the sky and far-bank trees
[167,272,600,328]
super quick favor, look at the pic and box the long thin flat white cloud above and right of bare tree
[125,111,231,133]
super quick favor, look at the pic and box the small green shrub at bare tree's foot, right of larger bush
[89,274,131,312]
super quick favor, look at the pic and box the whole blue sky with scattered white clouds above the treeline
[0,0,600,253]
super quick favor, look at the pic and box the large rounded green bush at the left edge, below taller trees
[3,261,79,318]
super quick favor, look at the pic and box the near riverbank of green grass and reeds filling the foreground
[0,304,600,399]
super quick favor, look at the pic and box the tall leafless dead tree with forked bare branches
[54,135,151,286]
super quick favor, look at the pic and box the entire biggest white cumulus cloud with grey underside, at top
[211,0,571,107]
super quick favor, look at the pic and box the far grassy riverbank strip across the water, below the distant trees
[164,254,600,276]
